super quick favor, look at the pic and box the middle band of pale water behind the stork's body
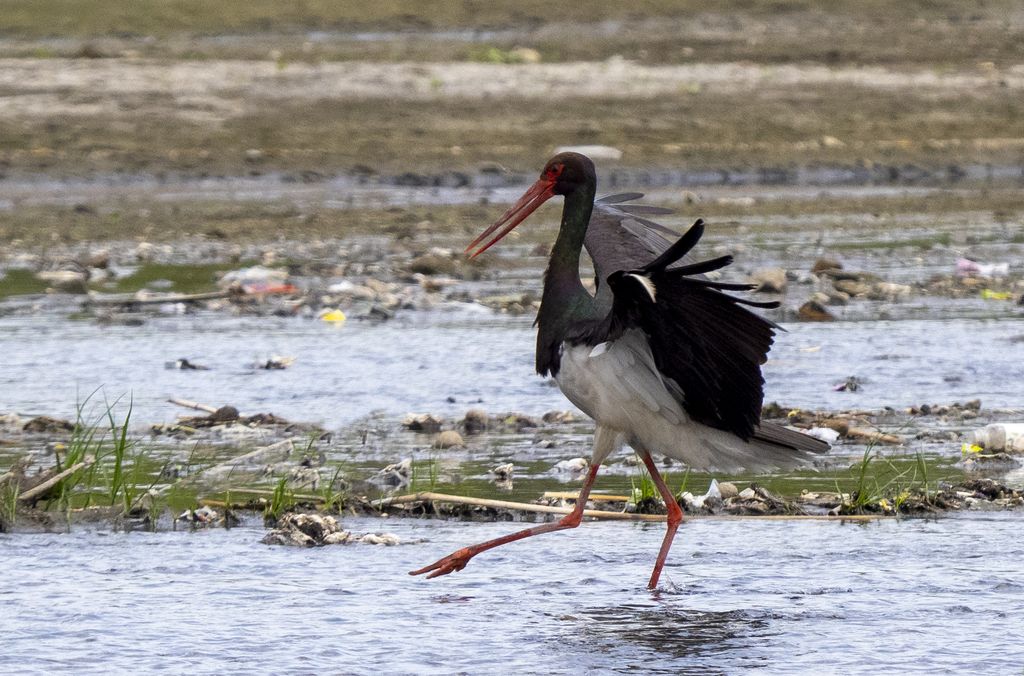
[0,305,1024,429]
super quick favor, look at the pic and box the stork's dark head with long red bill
[466,153,597,258]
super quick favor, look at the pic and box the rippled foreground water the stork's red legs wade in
[0,514,1024,673]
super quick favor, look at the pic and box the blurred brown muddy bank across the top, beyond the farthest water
[0,2,1024,183]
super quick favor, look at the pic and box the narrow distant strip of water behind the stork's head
[0,170,1024,209]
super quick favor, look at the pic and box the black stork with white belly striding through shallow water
[410,153,828,589]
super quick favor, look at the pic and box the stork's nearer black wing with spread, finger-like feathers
[591,220,777,439]
